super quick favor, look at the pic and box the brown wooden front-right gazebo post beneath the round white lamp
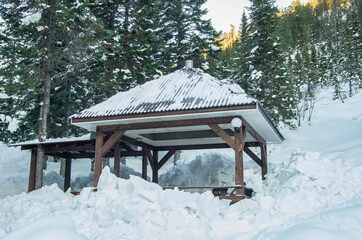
[234,126,246,195]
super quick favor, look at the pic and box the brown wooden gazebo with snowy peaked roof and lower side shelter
[17,68,284,201]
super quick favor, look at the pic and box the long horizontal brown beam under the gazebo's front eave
[100,116,234,132]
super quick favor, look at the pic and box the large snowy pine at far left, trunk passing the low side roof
[0,0,100,188]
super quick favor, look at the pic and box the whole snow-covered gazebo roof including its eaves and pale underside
[72,68,283,146]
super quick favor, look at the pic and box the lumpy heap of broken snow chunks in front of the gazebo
[0,167,247,239]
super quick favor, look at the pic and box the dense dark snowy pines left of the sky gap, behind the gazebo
[0,0,218,142]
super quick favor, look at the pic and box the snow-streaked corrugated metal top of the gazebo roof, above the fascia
[72,68,257,118]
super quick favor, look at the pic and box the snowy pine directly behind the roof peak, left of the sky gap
[159,0,217,72]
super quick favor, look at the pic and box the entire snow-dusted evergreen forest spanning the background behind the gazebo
[0,0,362,142]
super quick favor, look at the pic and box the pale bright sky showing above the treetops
[204,0,304,32]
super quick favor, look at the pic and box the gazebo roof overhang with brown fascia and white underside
[72,104,284,147]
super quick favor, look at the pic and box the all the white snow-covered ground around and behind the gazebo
[0,88,362,240]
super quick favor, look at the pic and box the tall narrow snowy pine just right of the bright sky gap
[248,0,294,123]
